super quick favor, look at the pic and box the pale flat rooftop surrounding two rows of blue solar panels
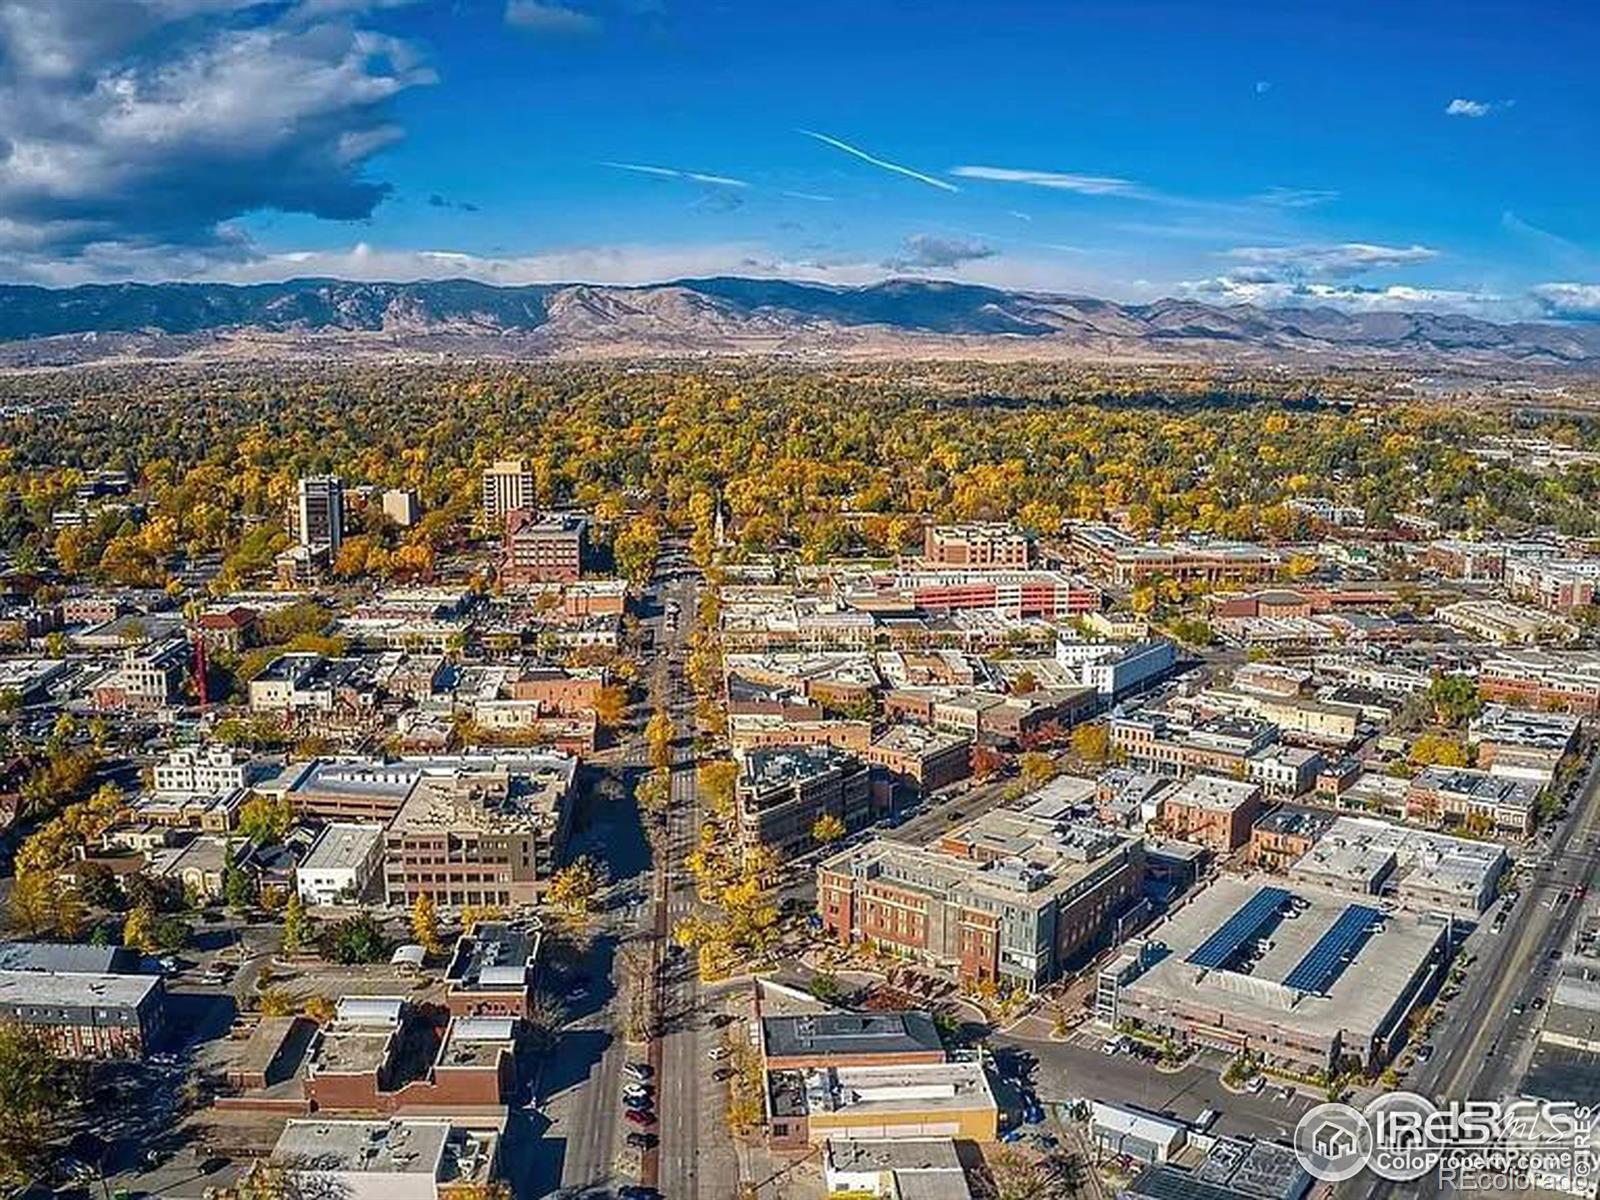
[1128,875,1445,1038]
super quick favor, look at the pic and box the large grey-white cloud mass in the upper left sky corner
[0,0,435,256]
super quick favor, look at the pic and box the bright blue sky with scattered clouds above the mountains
[0,0,1600,317]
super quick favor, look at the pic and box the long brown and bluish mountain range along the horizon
[0,277,1600,370]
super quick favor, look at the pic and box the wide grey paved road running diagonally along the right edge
[1342,758,1600,1200]
